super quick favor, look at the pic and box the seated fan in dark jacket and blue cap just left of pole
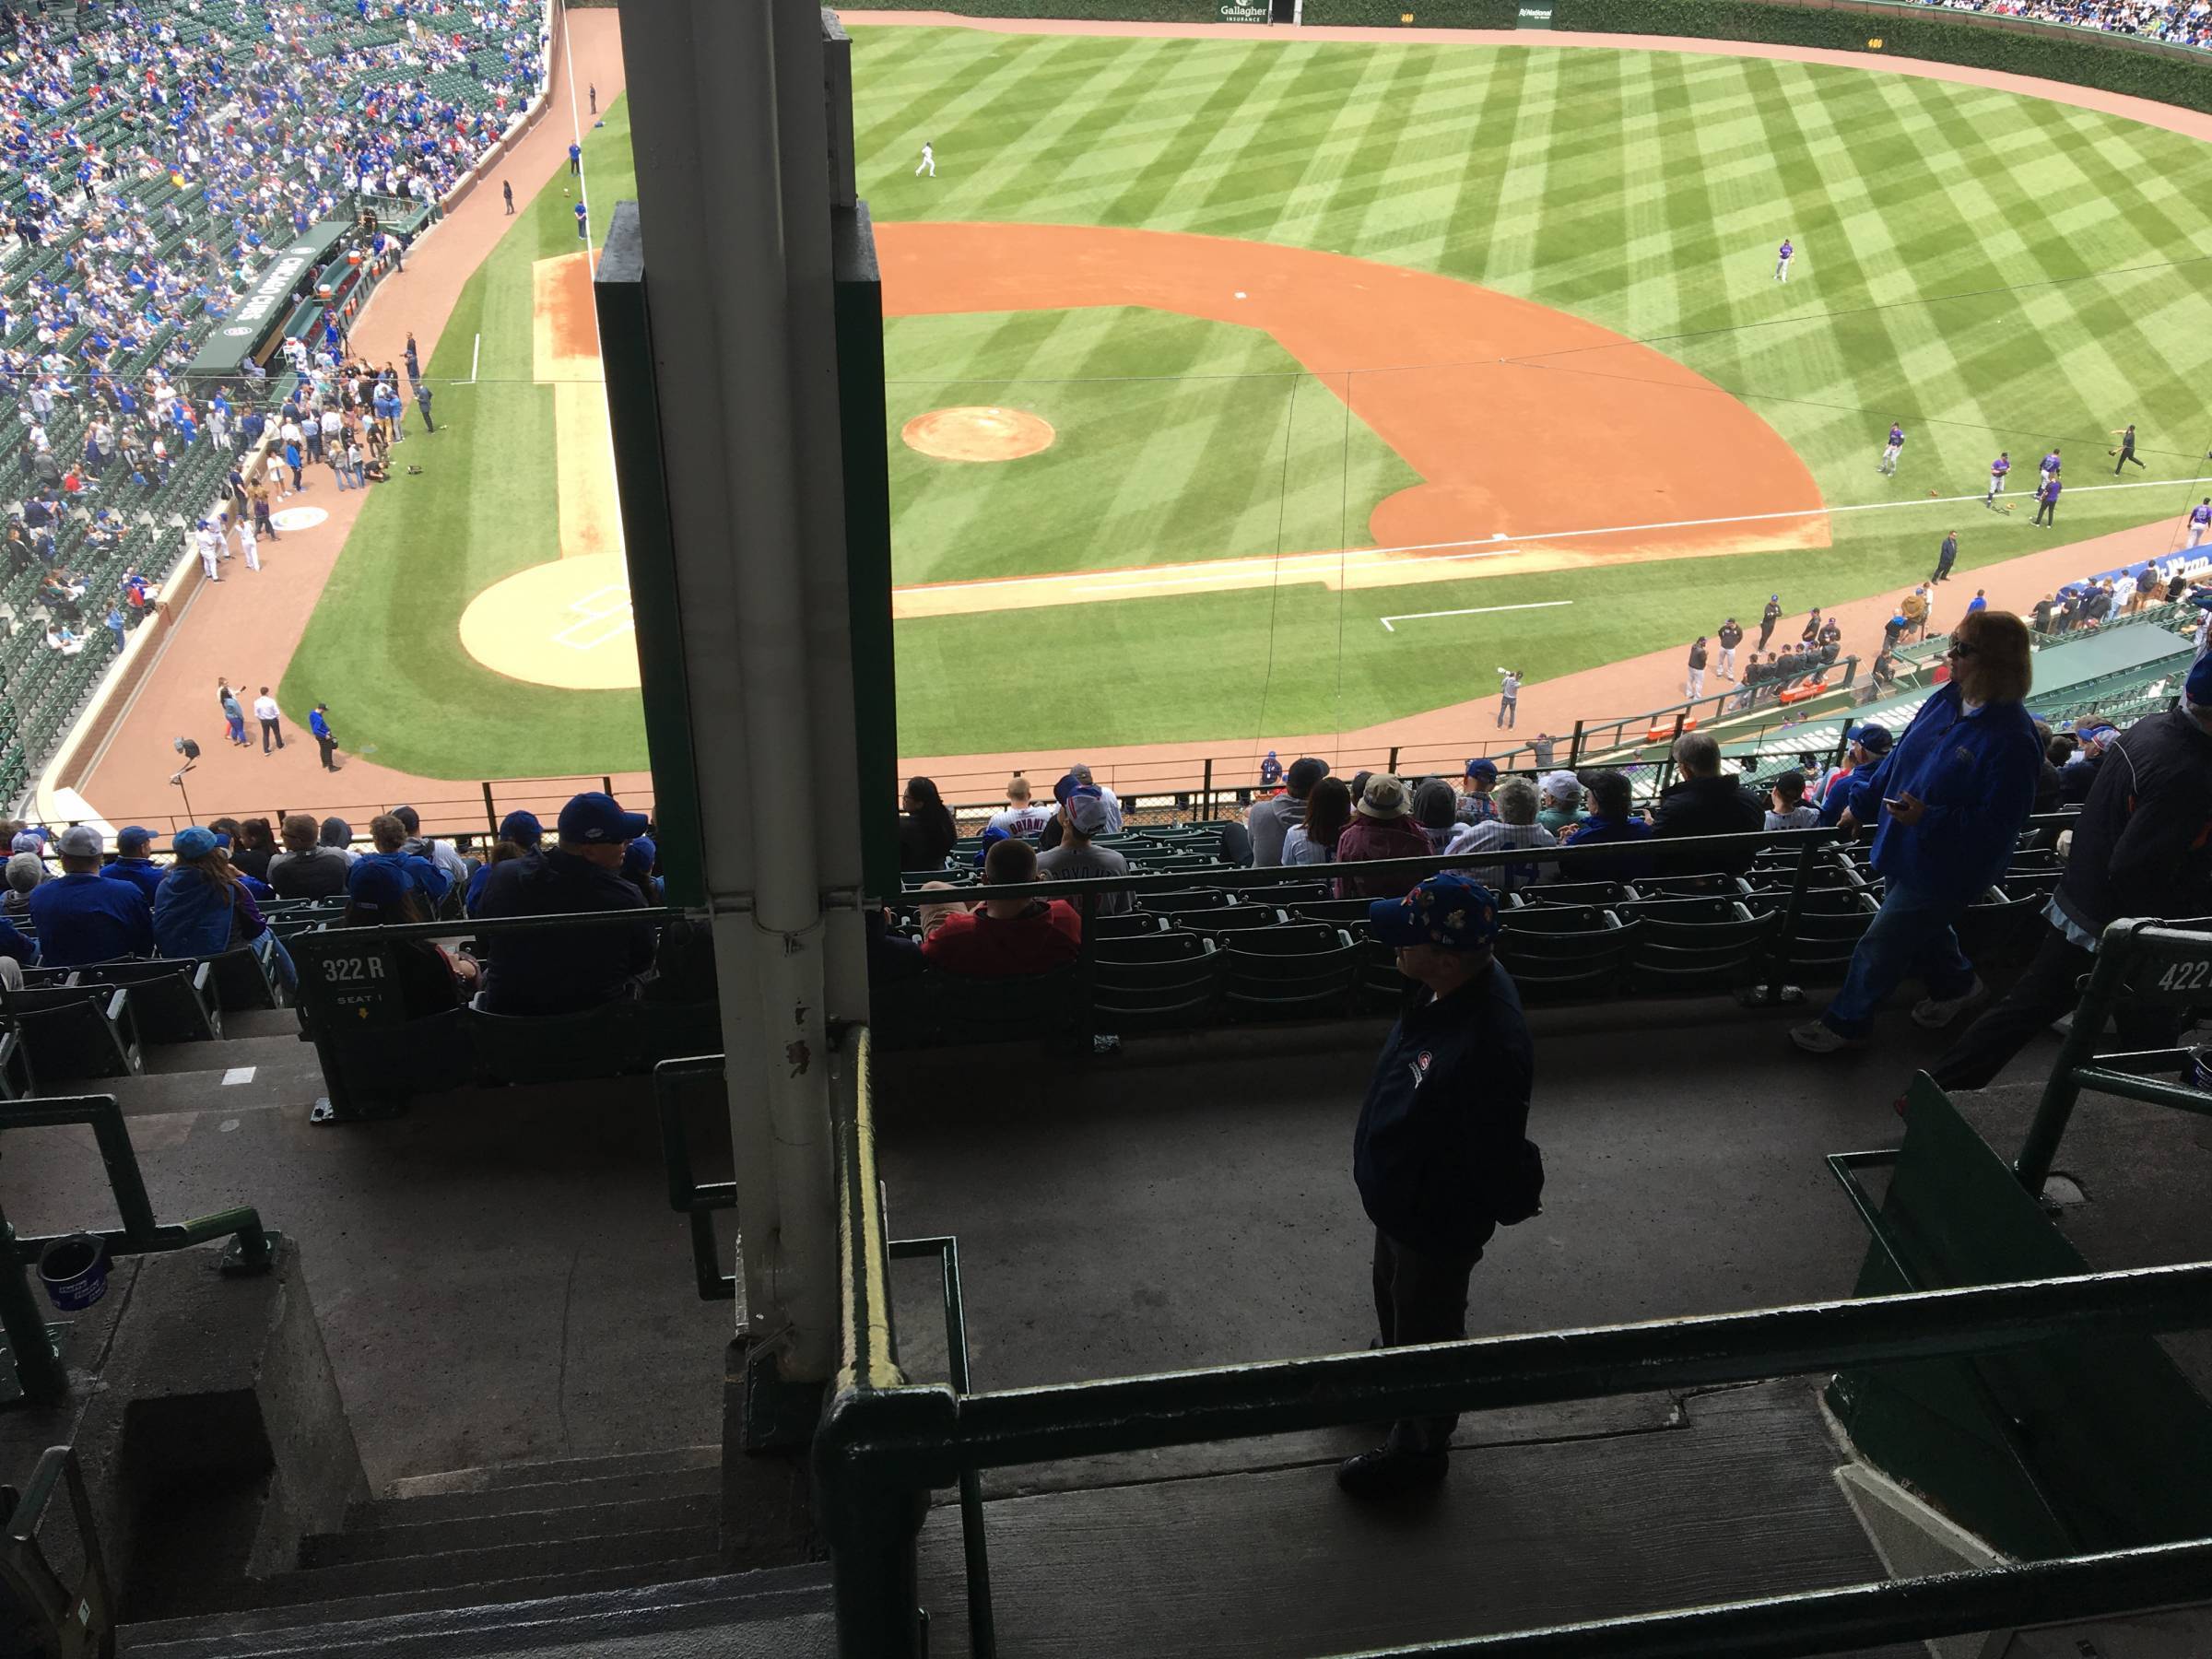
[476,790,653,1016]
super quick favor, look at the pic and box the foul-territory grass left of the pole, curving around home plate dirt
[278,98,646,779]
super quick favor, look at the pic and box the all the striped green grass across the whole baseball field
[286,35,2212,776]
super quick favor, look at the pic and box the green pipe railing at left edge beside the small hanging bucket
[0,1095,283,1405]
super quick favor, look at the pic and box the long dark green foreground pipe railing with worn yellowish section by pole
[814,1030,2212,1659]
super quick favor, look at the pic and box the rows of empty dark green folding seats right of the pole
[874,825,2059,1049]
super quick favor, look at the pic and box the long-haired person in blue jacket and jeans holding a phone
[1790,610,2044,1055]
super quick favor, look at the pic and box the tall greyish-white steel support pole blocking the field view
[621,0,867,1381]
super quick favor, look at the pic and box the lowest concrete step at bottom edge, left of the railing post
[117,1558,814,1659]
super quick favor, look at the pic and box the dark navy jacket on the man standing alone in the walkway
[1351,962,1535,1256]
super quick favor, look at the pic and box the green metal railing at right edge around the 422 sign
[2013,920,2212,1194]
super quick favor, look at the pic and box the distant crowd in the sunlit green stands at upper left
[0,0,544,796]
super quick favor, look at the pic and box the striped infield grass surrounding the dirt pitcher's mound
[883,305,1420,582]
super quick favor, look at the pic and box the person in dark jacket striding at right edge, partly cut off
[1929,657,2212,1088]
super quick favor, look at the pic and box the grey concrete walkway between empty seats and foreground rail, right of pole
[878,1005,2008,1387]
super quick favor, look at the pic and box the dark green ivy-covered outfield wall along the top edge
[834,0,2212,112]
